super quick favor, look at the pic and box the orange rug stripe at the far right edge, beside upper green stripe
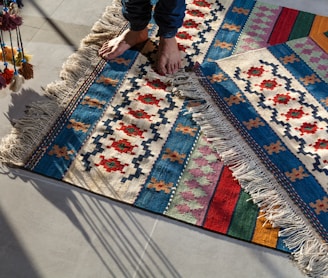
[310,15,328,53]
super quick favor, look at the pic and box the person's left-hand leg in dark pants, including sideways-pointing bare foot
[99,0,152,60]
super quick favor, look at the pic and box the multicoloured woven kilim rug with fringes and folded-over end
[0,0,328,276]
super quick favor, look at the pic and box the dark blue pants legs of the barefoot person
[122,0,186,38]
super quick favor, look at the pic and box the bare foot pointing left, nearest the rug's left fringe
[99,28,148,60]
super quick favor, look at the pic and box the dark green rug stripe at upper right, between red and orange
[289,12,315,40]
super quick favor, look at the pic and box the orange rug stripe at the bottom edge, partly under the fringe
[252,212,279,248]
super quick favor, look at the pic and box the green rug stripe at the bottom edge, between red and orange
[227,191,259,241]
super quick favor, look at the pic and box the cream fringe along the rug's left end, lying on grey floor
[0,0,126,166]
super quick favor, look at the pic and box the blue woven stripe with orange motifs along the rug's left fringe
[31,50,138,179]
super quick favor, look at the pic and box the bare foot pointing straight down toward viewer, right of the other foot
[157,37,181,75]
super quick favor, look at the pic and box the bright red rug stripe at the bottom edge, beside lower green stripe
[204,167,241,234]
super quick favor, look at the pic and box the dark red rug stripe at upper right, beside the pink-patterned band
[269,8,299,45]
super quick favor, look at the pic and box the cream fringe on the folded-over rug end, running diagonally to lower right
[169,72,328,277]
